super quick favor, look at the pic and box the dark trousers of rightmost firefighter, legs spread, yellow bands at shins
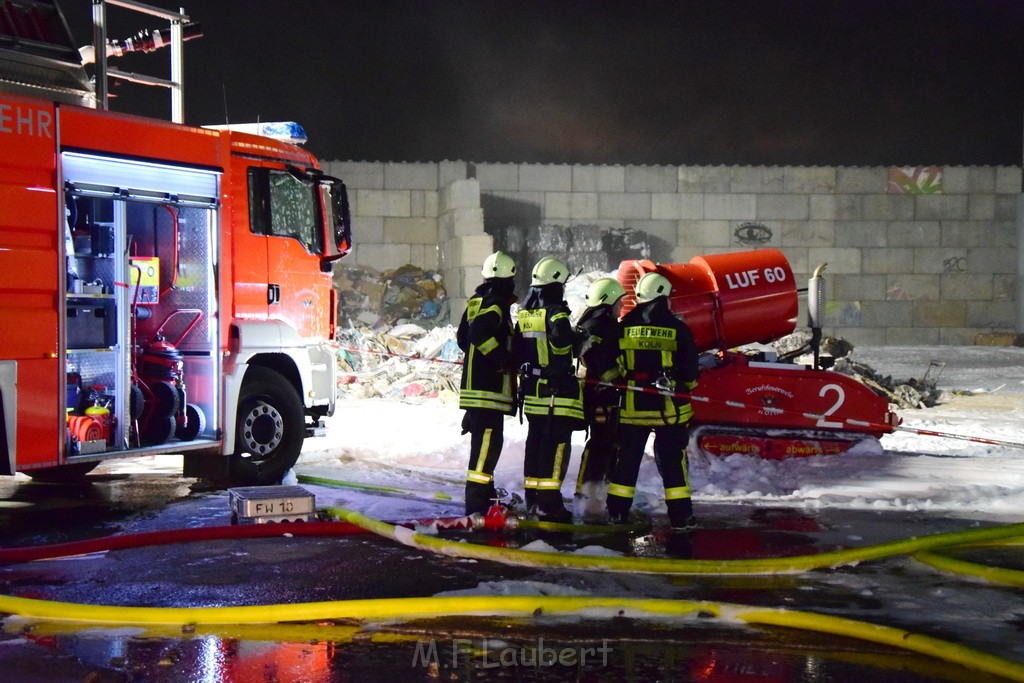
[606,424,693,527]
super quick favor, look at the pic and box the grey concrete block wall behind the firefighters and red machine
[326,157,1021,345]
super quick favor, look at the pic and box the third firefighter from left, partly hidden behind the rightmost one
[575,278,626,514]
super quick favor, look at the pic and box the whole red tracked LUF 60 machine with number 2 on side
[618,249,899,459]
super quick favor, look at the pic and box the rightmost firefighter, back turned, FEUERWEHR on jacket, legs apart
[606,272,699,530]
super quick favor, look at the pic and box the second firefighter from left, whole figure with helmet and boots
[515,256,583,522]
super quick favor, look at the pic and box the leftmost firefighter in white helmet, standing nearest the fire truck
[457,251,516,515]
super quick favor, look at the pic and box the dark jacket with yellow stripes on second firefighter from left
[515,285,583,420]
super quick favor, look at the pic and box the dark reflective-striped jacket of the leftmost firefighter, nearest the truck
[456,279,515,415]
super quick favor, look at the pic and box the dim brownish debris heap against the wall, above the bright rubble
[334,264,449,329]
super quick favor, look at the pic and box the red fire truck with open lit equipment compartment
[0,0,350,485]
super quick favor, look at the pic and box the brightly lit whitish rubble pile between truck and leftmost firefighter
[338,323,462,401]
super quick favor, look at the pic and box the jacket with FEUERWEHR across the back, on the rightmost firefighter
[618,297,699,427]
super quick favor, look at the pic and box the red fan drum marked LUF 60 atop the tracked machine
[617,249,799,350]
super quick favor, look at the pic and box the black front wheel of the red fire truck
[228,367,305,486]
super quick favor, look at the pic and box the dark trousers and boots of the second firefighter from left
[522,415,579,521]
